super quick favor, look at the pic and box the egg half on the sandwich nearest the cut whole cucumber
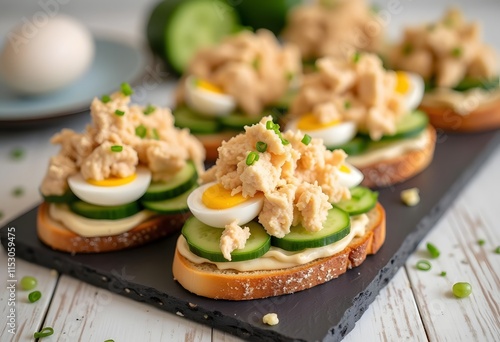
[186,76,236,117]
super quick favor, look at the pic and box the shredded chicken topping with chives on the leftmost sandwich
[40,92,205,196]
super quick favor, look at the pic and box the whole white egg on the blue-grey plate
[0,15,95,95]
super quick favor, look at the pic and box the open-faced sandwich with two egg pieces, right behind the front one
[286,52,436,187]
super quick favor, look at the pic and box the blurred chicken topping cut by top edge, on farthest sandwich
[282,0,384,70]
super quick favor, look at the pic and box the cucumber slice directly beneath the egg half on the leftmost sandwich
[69,201,142,220]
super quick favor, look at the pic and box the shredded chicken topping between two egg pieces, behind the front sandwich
[290,52,407,140]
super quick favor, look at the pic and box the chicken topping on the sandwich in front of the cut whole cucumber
[176,30,301,115]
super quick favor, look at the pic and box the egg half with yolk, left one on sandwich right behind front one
[286,114,357,147]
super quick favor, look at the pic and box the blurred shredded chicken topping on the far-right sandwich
[390,9,498,88]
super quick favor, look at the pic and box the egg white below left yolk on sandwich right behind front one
[286,119,357,147]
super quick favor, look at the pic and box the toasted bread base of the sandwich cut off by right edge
[420,99,500,133]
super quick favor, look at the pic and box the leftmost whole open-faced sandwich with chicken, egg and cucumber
[37,83,204,253]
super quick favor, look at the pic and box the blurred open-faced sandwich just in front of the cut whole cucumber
[173,30,301,160]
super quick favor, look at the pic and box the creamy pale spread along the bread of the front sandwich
[177,214,368,272]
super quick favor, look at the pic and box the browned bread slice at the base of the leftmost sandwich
[37,202,190,253]
